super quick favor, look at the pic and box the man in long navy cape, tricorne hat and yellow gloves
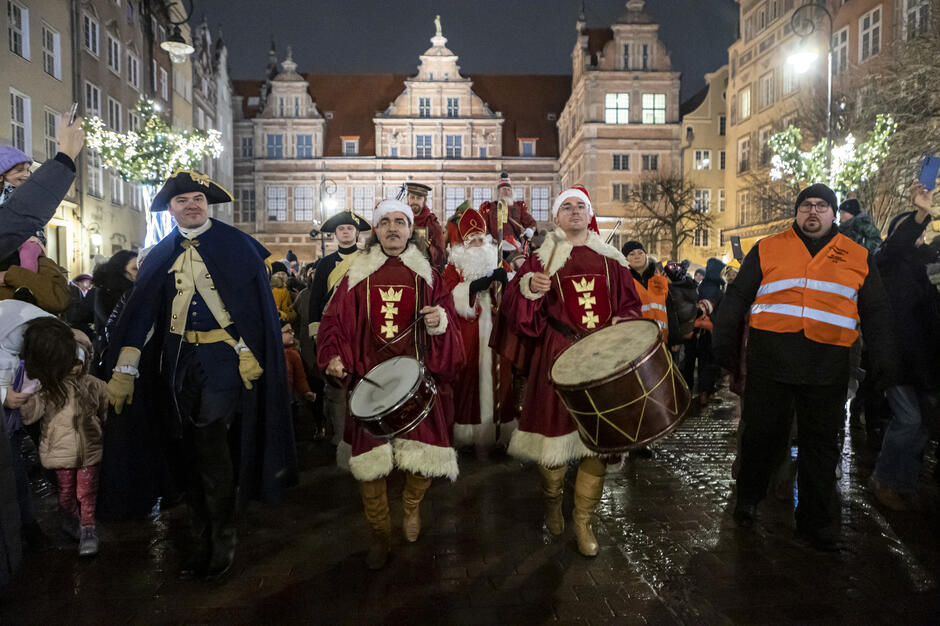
[107,171,296,580]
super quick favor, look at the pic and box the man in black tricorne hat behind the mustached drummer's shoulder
[308,210,372,446]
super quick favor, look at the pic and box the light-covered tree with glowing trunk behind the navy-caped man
[84,98,224,246]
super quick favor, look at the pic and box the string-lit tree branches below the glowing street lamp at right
[767,115,898,196]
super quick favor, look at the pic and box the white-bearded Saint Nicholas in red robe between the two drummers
[444,207,514,449]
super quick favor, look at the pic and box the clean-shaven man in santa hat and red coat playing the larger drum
[502,187,641,556]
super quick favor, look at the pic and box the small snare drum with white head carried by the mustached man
[349,356,437,439]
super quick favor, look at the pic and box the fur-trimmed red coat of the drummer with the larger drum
[502,232,641,467]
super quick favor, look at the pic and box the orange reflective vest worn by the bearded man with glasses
[750,227,868,346]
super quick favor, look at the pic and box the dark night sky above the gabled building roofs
[193,0,738,99]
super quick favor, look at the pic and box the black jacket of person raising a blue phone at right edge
[865,212,940,389]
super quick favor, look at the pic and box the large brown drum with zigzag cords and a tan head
[551,320,691,454]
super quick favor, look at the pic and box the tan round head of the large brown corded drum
[552,320,659,386]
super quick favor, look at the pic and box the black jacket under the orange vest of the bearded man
[712,223,897,385]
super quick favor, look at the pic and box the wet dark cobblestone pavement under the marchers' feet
[0,388,940,624]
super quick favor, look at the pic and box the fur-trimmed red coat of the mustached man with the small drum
[317,245,464,481]
